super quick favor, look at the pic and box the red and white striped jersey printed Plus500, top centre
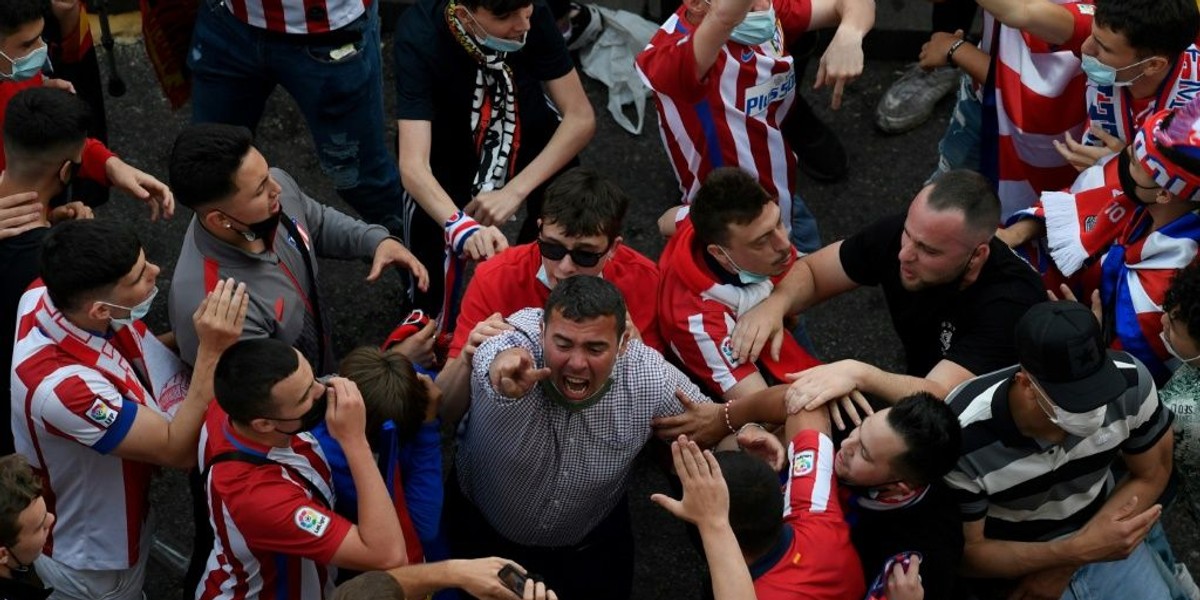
[637,0,812,224]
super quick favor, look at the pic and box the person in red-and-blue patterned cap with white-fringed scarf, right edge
[1000,102,1200,385]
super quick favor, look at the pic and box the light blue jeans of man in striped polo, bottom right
[1062,535,1172,600]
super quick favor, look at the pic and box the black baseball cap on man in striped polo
[1016,300,1126,414]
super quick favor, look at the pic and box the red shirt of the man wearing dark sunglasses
[449,242,664,359]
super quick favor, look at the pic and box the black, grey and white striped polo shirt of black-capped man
[946,350,1171,541]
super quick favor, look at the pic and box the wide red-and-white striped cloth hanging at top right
[980,0,1092,221]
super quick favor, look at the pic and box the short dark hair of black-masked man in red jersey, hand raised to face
[212,337,300,425]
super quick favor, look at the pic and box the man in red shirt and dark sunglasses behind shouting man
[437,167,664,420]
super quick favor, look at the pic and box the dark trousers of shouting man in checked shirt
[442,473,634,600]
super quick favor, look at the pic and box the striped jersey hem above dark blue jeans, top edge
[224,0,371,34]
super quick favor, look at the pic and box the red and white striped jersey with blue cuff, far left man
[11,281,177,570]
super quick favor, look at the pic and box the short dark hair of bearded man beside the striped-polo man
[887,391,962,485]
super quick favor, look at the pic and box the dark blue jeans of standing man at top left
[187,0,401,234]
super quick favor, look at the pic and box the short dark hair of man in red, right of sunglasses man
[690,167,774,245]
